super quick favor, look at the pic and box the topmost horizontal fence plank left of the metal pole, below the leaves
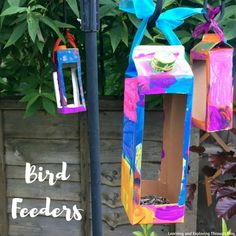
[4,110,79,140]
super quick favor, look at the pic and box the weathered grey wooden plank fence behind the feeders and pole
[0,100,198,236]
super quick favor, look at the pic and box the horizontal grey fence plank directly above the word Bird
[5,138,79,166]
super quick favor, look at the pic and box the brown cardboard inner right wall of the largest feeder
[160,94,187,202]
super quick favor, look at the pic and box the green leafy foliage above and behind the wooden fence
[0,0,236,116]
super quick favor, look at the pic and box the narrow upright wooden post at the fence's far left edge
[0,110,8,236]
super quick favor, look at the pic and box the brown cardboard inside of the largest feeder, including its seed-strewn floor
[140,94,187,205]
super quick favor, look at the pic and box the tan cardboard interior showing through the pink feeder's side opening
[192,60,207,121]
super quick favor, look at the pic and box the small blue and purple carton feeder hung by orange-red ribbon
[53,30,86,114]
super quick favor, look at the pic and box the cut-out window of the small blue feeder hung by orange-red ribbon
[63,63,81,107]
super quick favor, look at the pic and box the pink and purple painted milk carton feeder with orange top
[191,34,233,132]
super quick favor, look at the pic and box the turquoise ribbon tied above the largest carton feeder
[120,0,203,77]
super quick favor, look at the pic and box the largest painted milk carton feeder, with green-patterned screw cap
[121,46,193,224]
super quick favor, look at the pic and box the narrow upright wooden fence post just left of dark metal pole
[79,114,91,236]
